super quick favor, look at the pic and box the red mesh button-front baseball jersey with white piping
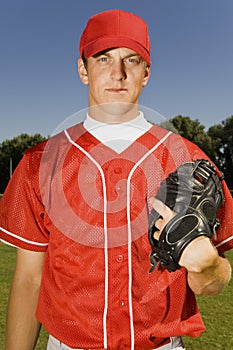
[0,124,233,350]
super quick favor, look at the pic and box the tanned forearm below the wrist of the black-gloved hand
[188,256,231,296]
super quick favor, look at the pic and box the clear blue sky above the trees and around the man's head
[0,0,233,142]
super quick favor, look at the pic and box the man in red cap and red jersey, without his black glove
[0,10,233,350]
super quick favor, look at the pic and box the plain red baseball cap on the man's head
[79,10,150,65]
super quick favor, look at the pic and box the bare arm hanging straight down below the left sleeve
[5,249,45,350]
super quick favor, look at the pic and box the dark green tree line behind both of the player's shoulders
[0,115,233,193]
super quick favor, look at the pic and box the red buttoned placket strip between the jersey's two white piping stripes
[104,158,133,349]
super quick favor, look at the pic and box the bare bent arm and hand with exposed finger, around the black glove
[151,198,231,295]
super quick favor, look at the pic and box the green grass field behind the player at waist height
[0,244,233,350]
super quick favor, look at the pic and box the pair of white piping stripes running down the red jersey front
[64,130,172,350]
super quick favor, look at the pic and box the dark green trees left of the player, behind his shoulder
[0,134,45,193]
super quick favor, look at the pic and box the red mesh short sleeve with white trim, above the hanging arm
[0,145,49,252]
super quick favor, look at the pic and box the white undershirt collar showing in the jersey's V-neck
[83,112,152,153]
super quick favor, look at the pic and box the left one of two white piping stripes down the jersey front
[64,130,108,349]
